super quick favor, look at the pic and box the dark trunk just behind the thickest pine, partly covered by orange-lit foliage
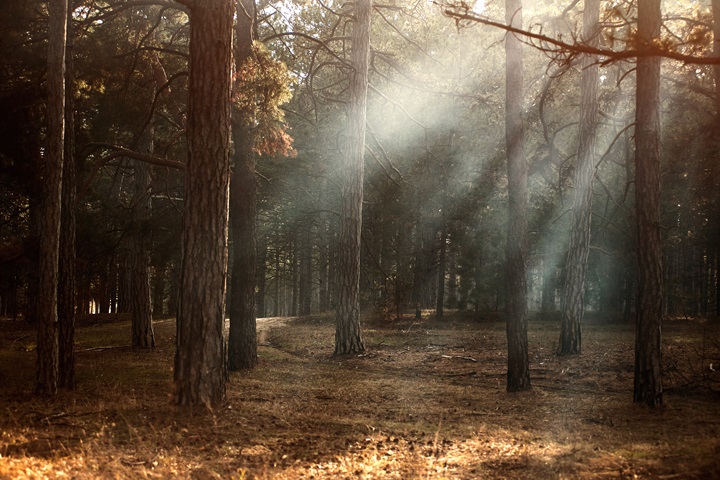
[228,0,257,371]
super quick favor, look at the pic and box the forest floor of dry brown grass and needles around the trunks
[0,315,720,479]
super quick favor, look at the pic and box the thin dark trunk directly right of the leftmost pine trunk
[58,3,77,390]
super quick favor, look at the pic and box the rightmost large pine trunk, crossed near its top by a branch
[634,0,663,406]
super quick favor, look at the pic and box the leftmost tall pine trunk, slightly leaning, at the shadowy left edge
[35,0,68,395]
